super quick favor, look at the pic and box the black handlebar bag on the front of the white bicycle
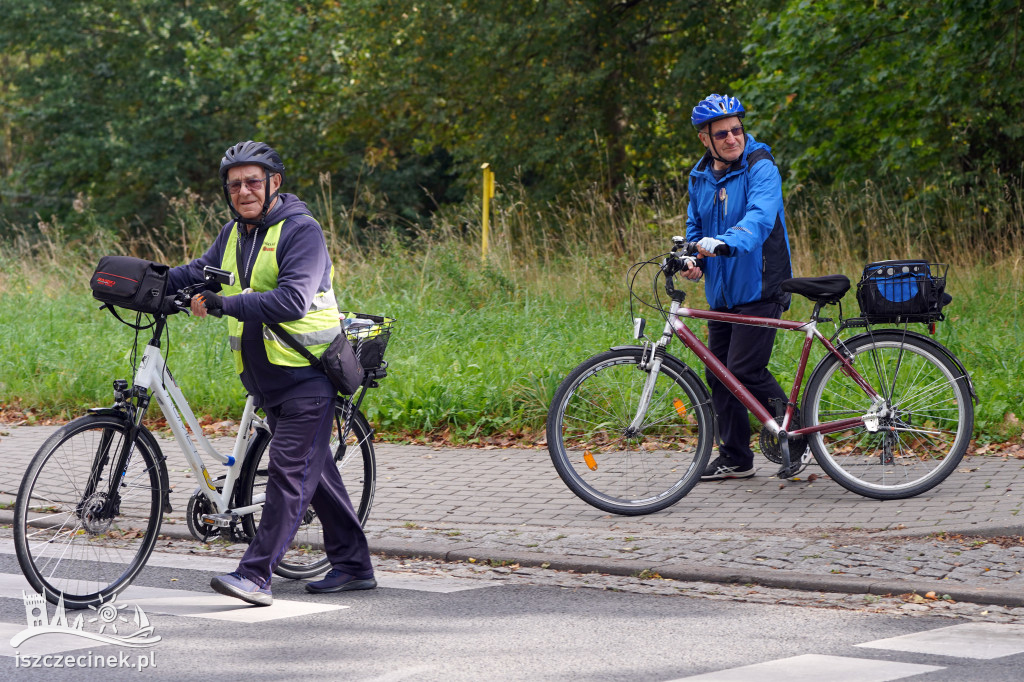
[89,256,171,314]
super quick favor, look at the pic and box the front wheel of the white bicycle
[14,415,164,609]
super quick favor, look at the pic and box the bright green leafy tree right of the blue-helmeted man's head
[738,0,1024,183]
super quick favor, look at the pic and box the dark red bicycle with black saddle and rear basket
[547,237,977,515]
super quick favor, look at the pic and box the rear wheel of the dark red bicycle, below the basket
[802,330,974,500]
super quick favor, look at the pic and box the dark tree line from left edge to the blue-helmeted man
[0,0,777,232]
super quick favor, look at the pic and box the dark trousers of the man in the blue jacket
[705,301,788,469]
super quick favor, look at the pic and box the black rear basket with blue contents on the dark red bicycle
[857,260,952,324]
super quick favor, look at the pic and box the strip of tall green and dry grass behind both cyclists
[0,175,1024,440]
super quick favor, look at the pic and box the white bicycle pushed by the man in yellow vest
[14,268,394,608]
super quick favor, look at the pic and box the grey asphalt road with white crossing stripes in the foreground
[0,553,1024,682]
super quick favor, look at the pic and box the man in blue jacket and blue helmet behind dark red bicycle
[686,94,793,480]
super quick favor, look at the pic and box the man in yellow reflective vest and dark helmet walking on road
[168,140,377,606]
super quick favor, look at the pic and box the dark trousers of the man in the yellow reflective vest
[238,397,374,587]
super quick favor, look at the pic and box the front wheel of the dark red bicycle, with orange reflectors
[547,347,715,516]
